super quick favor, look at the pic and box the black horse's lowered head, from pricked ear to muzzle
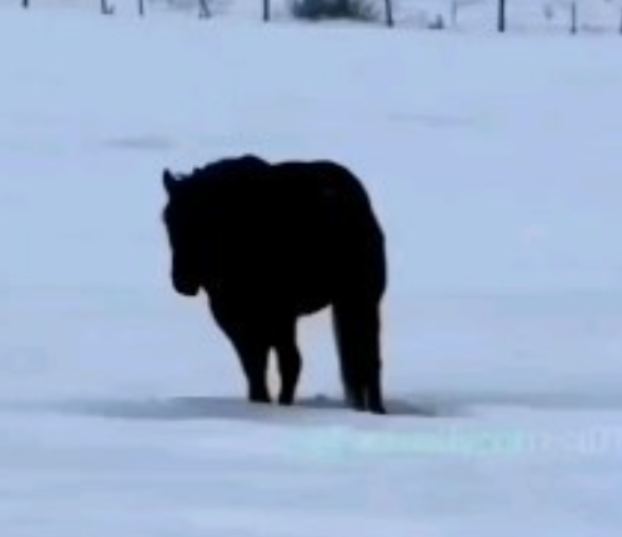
[162,169,201,296]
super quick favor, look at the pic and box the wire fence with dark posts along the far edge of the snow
[11,0,622,35]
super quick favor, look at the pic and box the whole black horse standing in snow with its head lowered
[163,155,387,414]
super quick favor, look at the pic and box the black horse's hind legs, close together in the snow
[333,297,386,414]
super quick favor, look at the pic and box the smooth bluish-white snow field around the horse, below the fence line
[0,8,622,537]
